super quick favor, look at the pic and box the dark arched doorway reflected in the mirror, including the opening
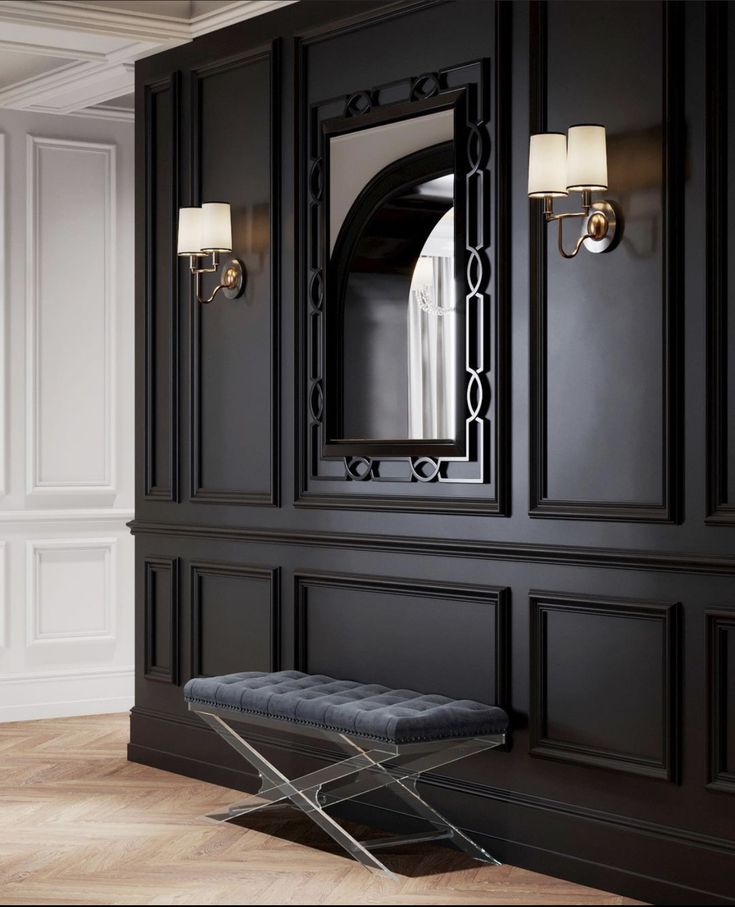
[328,142,457,439]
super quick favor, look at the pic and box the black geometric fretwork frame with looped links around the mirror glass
[297,31,505,513]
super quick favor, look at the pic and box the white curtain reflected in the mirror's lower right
[408,255,457,438]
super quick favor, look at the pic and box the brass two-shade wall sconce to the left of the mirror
[177,202,245,305]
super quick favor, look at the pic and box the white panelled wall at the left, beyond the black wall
[0,110,133,721]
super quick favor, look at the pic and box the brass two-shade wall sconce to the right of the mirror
[528,124,622,258]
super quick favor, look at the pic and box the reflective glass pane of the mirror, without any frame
[327,110,464,442]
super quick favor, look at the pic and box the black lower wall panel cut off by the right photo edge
[705,610,735,794]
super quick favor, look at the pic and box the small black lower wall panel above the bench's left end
[191,562,280,677]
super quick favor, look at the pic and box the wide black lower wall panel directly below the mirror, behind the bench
[295,574,510,705]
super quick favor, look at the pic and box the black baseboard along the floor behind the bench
[128,710,735,904]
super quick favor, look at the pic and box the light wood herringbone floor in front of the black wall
[0,715,636,904]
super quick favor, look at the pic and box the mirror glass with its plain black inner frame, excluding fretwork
[320,91,467,457]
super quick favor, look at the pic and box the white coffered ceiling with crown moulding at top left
[0,0,296,120]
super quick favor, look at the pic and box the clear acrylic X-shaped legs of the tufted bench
[189,703,505,879]
